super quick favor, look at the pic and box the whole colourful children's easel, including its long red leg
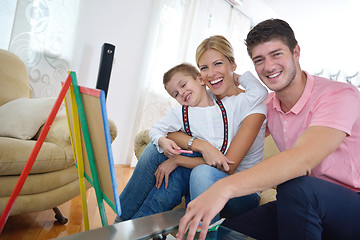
[0,72,121,233]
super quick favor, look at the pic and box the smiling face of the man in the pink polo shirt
[251,39,300,92]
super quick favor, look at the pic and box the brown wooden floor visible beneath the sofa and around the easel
[0,166,134,240]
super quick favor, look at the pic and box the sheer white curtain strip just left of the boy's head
[135,0,188,134]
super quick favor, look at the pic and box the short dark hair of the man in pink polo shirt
[245,19,297,57]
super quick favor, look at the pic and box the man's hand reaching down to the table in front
[176,183,228,239]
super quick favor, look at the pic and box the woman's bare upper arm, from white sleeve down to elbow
[225,113,266,174]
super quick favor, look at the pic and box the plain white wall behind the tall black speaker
[73,0,152,164]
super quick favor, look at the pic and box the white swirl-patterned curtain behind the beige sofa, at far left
[9,0,81,97]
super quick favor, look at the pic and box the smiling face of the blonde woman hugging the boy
[199,49,236,99]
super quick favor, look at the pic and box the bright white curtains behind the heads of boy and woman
[129,0,251,166]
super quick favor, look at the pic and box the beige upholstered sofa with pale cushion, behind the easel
[0,49,117,224]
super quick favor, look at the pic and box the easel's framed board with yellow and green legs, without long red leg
[65,72,121,230]
